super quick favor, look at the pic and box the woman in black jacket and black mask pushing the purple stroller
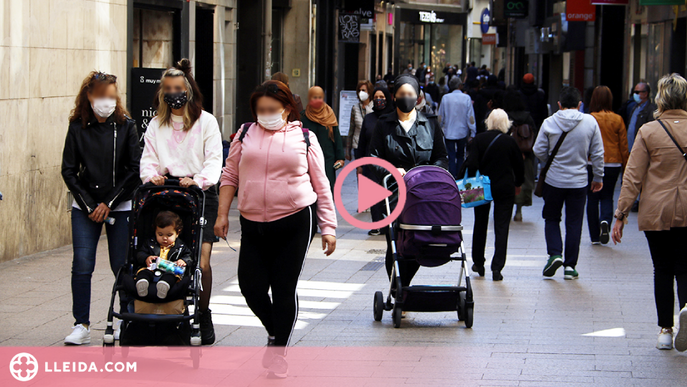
[369,75,448,292]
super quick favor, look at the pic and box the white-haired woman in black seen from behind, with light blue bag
[461,109,525,281]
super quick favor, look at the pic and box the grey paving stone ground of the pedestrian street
[0,174,687,387]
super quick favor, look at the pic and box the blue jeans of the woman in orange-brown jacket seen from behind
[587,167,621,242]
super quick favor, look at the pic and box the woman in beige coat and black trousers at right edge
[612,74,687,351]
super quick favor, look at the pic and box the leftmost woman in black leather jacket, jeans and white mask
[62,71,141,345]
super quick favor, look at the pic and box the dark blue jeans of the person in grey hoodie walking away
[542,183,587,268]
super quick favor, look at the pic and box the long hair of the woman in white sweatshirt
[153,58,203,130]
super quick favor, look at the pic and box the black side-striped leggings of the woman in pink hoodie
[238,205,317,347]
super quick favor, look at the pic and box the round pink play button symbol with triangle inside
[334,157,406,230]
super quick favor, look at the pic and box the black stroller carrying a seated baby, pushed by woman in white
[103,179,205,368]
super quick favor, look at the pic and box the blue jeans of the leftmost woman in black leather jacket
[72,208,131,325]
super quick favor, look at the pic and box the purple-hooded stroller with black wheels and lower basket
[374,166,474,328]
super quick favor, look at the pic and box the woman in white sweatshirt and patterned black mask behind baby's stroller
[141,59,222,344]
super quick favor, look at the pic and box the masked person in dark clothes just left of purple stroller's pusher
[355,87,396,235]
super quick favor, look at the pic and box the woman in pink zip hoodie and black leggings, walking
[215,81,336,377]
